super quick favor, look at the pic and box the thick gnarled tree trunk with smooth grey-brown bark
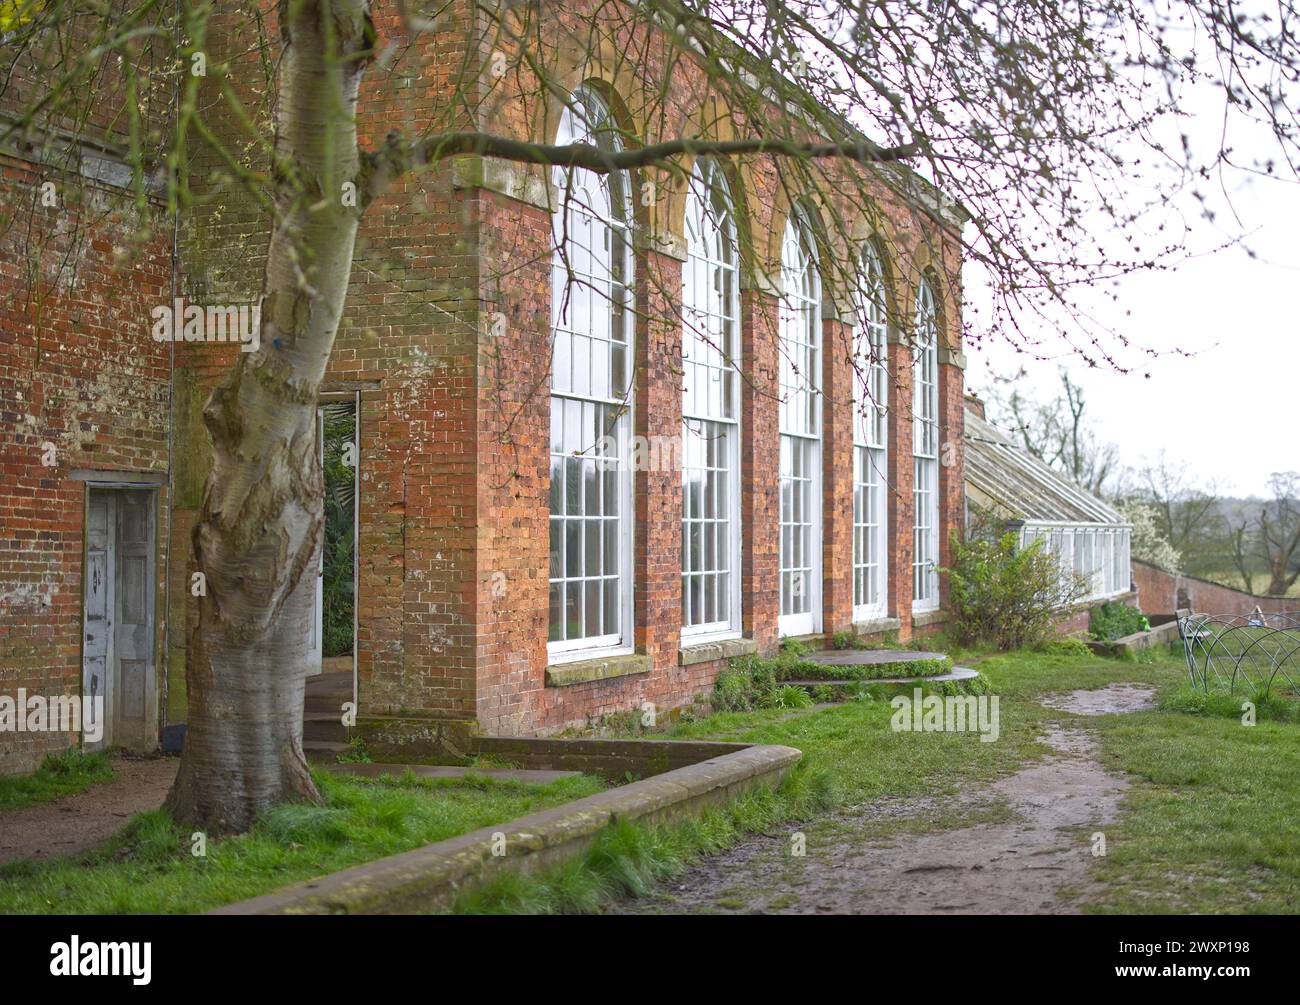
[166,0,373,833]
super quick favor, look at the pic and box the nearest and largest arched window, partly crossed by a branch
[549,90,632,657]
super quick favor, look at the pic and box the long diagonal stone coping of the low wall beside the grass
[212,745,801,915]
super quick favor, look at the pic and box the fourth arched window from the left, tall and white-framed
[853,243,889,621]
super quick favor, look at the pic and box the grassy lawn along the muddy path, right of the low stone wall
[458,642,1300,913]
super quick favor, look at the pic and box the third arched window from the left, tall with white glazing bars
[779,211,822,636]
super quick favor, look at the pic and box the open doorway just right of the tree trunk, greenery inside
[312,394,360,679]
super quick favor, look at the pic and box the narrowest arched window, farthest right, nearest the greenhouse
[911,278,939,611]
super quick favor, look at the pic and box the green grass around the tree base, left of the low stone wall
[0,772,603,914]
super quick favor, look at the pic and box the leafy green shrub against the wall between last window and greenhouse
[941,532,1087,651]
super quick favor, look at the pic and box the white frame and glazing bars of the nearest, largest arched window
[546,88,636,663]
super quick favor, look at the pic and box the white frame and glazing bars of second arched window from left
[681,160,741,642]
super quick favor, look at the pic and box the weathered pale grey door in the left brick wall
[82,488,157,750]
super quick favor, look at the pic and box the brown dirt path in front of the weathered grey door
[0,755,181,865]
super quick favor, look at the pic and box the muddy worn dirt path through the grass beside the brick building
[621,684,1153,914]
